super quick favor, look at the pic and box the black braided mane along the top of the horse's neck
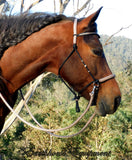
[0,13,67,58]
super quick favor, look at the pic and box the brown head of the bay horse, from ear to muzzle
[56,8,121,116]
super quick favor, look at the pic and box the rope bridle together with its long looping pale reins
[0,19,115,138]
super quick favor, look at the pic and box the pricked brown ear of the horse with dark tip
[80,7,103,29]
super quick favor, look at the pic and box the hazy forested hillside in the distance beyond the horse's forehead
[101,35,132,73]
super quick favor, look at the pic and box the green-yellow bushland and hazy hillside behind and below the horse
[0,35,132,160]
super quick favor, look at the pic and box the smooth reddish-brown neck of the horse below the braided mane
[0,25,71,94]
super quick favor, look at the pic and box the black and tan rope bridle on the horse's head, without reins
[58,19,115,112]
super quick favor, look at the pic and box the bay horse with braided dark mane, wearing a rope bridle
[0,8,121,134]
